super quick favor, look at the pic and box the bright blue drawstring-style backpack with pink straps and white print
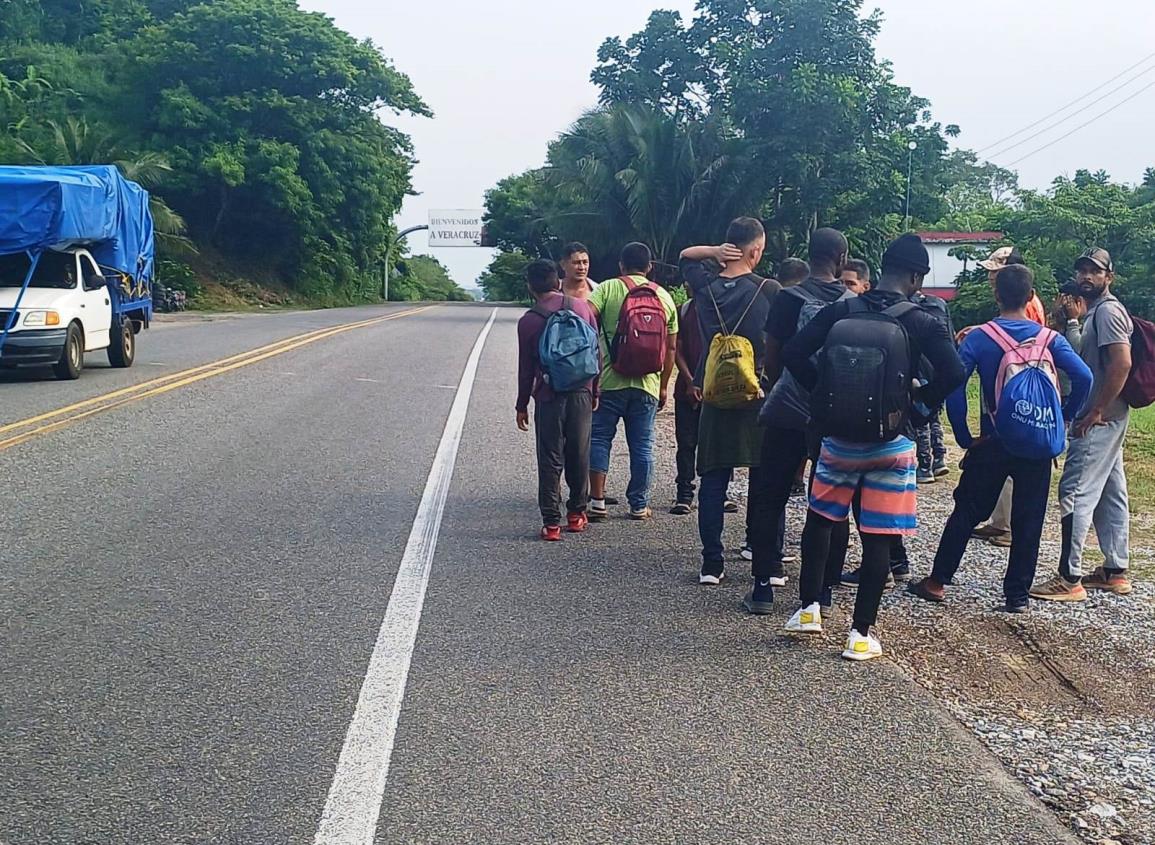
[978,321,1067,459]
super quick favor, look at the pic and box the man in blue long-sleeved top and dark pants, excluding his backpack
[910,264,1091,613]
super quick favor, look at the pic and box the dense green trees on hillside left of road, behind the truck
[0,0,467,307]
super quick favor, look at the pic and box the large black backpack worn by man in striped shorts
[810,297,918,443]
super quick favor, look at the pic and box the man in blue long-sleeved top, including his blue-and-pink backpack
[910,264,1091,613]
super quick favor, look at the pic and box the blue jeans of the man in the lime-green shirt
[589,388,657,510]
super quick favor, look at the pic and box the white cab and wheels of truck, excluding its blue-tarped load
[0,248,131,379]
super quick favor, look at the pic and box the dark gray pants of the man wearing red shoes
[534,390,594,525]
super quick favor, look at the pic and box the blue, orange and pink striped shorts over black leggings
[810,436,918,534]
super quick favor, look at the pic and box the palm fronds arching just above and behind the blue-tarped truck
[21,117,196,253]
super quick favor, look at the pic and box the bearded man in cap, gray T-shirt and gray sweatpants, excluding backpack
[1030,248,1134,601]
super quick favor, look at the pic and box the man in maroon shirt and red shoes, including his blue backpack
[516,261,602,541]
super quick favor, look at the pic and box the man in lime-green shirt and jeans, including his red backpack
[589,244,678,522]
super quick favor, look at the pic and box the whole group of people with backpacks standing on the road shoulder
[516,227,1134,660]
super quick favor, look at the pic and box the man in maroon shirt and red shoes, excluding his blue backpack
[516,261,597,540]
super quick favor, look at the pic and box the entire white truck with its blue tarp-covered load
[0,166,156,379]
